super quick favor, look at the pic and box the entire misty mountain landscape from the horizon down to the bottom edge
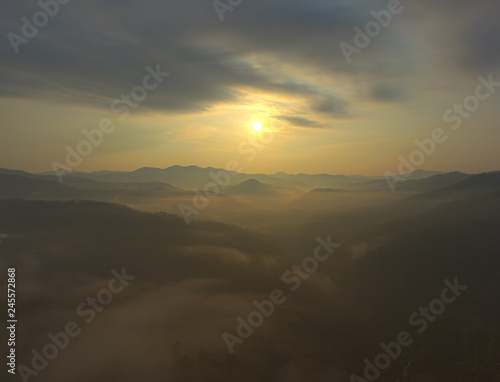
[0,166,500,382]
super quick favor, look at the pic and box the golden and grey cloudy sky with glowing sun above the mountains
[0,0,500,175]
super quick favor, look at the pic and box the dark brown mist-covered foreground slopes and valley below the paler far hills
[0,195,500,382]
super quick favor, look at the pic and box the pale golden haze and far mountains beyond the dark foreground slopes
[0,166,500,231]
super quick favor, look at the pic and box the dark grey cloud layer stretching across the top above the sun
[0,0,500,121]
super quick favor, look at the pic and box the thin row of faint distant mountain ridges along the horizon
[5,166,499,201]
